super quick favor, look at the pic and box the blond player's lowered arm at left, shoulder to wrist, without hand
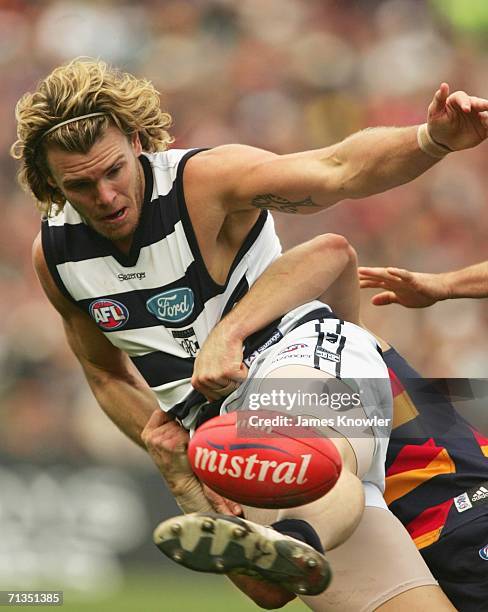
[33,236,164,447]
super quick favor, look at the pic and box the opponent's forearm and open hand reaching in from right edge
[359,261,488,308]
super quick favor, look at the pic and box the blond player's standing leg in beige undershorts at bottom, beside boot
[303,500,454,612]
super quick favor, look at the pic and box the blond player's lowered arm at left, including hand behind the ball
[33,232,240,513]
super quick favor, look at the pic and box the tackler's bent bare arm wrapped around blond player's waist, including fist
[192,234,359,399]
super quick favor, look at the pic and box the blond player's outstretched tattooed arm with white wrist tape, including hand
[187,83,488,214]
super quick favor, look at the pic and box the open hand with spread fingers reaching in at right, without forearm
[358,266,449,308]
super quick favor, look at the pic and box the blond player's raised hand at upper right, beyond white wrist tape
[427,83,488,151]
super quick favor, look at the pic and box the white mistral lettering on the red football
[195,446,312,484]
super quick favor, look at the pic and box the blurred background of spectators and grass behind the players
[0,0,488,611]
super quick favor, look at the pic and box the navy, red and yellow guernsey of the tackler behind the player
[383,348,488,549]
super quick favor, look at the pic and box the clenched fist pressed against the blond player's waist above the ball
[191,320,247,401]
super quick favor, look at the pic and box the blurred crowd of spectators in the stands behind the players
[0,0,488,462]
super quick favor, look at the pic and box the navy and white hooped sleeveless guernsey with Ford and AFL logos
[42,149,281,424]
